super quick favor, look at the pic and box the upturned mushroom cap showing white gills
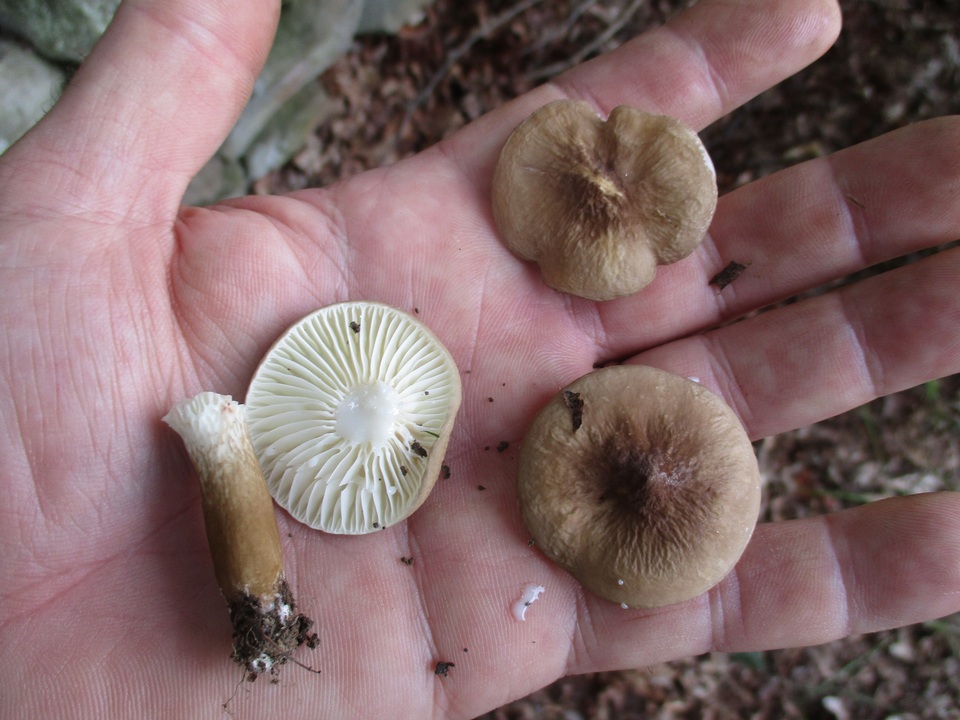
[246,302,460,534]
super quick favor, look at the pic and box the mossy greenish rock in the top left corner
[0,0,120,62]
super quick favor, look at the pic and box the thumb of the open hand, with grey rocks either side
[3,0,280,217]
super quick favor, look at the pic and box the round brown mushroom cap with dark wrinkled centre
[518,365,760,607]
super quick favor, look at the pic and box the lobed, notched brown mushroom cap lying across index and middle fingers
[492,100,717,300]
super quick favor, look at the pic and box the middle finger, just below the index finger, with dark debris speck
[598,117,960,366]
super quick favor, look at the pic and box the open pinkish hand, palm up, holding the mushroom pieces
[0,0,960,719]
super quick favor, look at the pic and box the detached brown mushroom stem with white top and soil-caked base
[163,392,317,680]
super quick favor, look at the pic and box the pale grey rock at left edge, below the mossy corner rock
[0,39,66,153]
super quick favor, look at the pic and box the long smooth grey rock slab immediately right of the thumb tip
[220,0,363,158]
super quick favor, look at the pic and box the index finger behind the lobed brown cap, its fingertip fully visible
[443,0,840,181]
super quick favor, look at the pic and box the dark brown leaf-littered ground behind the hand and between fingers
[256,0,960,720]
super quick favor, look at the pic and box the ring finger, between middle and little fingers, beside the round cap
[629,248,960,438]
